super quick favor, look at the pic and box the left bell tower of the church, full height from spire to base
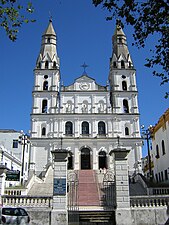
[31,20,60,174]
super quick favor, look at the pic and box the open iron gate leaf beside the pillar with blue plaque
[67,171,79,225]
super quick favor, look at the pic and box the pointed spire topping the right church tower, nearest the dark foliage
[112,20,132,67]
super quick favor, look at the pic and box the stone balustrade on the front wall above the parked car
[1,195,52,208]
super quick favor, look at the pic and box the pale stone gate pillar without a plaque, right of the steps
[110,148,132,225]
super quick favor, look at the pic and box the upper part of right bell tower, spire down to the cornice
[109,21,138,114]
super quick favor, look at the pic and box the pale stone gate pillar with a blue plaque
[51,149,68,225]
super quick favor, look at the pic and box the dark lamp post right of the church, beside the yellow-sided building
[141,125,153,182]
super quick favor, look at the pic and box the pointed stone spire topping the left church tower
[36,19,59,69]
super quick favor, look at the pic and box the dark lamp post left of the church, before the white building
[19,131,30,185]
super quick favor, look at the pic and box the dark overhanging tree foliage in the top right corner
[92,0,169,98]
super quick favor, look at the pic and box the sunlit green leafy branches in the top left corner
[0,0,34,41]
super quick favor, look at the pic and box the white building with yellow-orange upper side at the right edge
[151,108,169,183]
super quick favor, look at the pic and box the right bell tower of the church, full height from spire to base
[109,21,142,170]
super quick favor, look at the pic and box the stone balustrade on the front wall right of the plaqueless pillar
[130,195,169,208]
